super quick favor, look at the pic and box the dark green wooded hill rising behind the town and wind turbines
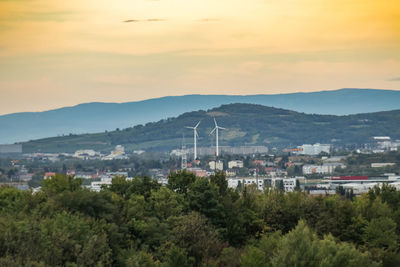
[23,104,400,152]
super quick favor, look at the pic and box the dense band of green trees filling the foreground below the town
[0,172,400,266]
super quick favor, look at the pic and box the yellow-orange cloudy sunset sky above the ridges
[0,0,400,114]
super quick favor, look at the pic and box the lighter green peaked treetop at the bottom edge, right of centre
[241,221,379,267]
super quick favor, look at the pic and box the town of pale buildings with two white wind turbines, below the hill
[0,132,400,195]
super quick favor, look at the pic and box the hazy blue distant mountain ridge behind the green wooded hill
[0,89,400,143]
